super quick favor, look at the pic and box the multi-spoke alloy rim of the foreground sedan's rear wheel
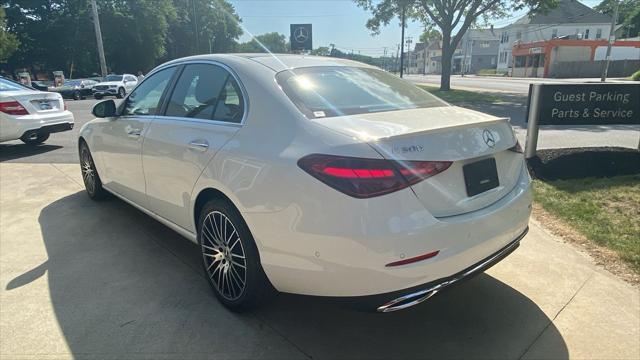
[201,211,247,301]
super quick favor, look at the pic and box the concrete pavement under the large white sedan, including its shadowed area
[0,163,640,359]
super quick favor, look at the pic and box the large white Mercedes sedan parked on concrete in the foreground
[78,54,532,312]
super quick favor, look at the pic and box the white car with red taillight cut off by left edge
[0,77,74,145]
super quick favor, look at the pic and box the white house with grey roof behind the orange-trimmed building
[496,0,611,72]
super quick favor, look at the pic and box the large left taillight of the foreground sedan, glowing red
[298,154,451,199]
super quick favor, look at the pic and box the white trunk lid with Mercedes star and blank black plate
[314,106,522,217]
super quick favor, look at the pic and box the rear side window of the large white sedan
[165,64,244,123]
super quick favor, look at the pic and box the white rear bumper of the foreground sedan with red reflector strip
[248,160,532,298]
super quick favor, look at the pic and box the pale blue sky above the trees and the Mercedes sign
[229,0,600,56]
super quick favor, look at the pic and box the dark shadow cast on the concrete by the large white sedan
[25,192,568,359]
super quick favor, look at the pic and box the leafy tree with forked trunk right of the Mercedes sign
[354,0,557,90]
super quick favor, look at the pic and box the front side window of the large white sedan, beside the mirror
[122,67,176,115]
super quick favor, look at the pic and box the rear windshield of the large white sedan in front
[276,66,448,119]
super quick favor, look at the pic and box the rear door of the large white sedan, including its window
[142,63,245,229]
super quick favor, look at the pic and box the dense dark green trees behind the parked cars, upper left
[0,0,242,77]
